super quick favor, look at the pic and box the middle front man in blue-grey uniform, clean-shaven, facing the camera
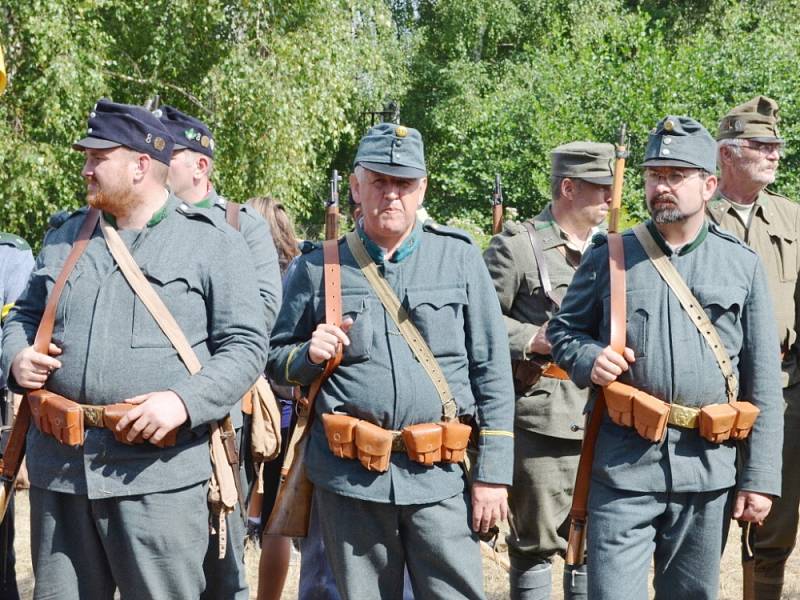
[269,123,513,599]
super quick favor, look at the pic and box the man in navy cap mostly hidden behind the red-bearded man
[154,105,281,600]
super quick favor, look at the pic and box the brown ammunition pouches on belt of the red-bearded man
[27,389,178,448]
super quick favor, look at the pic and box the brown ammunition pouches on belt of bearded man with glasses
[603,381,759,444]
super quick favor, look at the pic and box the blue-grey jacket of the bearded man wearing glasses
[547,224,783,496]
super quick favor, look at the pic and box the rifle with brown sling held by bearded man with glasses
[565,125,628,566]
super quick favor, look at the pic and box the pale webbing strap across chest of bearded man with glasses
[633,223,739,402]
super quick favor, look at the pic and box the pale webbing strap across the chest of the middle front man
[345,231,456,421]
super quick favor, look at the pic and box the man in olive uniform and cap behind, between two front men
[483,142,614,600]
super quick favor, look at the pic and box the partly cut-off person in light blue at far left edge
[0,233,33,600]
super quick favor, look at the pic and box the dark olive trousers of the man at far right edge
[755,384,800,600]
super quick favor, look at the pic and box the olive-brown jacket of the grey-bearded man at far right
[707,189,800,386]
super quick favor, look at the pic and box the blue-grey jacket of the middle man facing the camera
[268,222,514,505]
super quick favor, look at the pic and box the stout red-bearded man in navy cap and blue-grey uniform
[0,100,268,600]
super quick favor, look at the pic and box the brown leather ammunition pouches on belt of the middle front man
[322,413,472,473]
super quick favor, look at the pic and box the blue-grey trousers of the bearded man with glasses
[587,481,733,600]
